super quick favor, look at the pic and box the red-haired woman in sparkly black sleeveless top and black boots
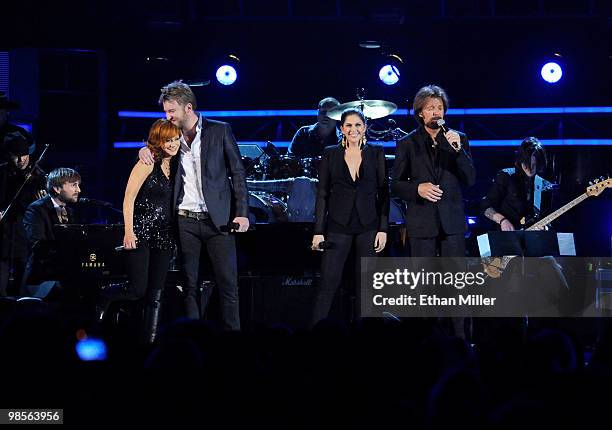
[97,119,181,343]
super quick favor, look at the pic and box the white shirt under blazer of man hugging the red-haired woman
[178,115,207,212]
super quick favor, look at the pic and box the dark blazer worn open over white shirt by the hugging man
[172,117,249,228]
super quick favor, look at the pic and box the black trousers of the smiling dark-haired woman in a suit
[310,231,377,326]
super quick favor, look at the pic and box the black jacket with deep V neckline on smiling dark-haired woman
[314,144,389,234]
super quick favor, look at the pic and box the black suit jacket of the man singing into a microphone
[391,127,476,237]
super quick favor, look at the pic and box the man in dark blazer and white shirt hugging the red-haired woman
[140,81,249,330]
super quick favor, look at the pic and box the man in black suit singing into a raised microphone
[391,85,476,257]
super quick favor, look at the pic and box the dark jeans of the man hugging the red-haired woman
[178,216,240,330]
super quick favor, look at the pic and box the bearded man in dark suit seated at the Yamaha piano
[23,167,81,294]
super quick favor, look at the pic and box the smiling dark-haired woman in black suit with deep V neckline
[311,108,389,325]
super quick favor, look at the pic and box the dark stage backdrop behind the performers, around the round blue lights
[0,0,612,255]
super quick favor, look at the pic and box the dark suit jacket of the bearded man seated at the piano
[23,196,76,250]
